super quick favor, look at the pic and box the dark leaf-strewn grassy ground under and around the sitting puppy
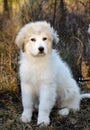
[0,85,90,130]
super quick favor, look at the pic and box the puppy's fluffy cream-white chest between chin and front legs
[20,59,53,86]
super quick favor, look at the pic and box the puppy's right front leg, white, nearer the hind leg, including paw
[37,85,56,125]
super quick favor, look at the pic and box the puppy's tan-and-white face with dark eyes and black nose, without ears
[24,27,52,56]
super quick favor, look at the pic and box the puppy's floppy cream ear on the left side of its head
[15,25,28,51]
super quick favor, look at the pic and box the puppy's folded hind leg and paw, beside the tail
[58,78,80,115]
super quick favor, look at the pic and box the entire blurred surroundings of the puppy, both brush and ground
[0,0,90,130]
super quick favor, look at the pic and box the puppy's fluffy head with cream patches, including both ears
[15,21,59,56]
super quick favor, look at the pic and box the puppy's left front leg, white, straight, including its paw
[21,84,33,123]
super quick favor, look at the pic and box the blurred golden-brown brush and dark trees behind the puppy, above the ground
[0,0,90,92]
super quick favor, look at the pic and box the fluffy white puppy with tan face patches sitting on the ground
[15,21,90,125]
